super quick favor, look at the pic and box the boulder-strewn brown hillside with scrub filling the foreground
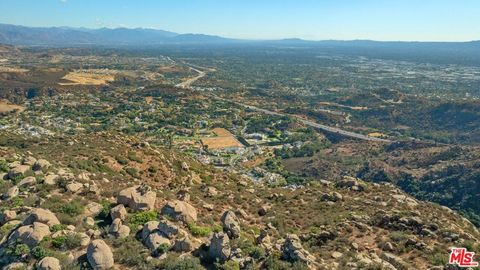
[0,134,480,269]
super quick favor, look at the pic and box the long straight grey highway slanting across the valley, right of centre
[211,95,391,142]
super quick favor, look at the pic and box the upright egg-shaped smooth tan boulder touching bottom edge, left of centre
[87,239,114,270]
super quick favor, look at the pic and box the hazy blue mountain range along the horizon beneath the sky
[0,24,480,49]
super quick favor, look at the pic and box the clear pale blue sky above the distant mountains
[0,0,480,41]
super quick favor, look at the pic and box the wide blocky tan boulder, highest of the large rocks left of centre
[117,185,157,211]
